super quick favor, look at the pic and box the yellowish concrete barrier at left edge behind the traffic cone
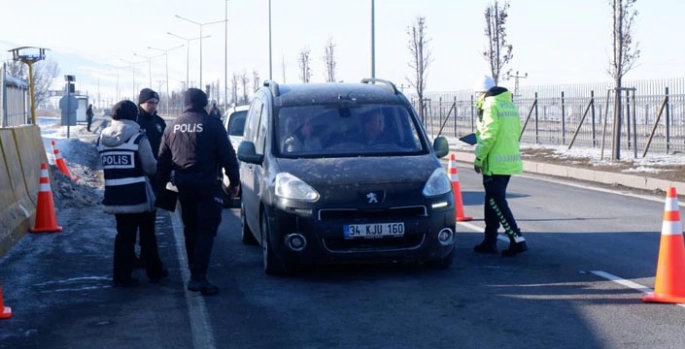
[0,126,47,257]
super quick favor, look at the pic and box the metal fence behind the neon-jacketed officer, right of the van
[410,78,685,156]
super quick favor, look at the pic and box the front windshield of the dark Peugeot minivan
[275,104,428,157]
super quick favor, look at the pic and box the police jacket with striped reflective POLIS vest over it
[97,120,157,214]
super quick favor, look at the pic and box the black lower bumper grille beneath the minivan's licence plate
[322,234,426,253]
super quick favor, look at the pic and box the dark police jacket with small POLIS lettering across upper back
[157,108,240,186]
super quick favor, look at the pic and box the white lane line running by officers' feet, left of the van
[170,211,216,349]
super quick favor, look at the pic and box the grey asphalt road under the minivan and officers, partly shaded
[0,167,685,348]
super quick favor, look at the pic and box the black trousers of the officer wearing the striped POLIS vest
[113,212,163,281]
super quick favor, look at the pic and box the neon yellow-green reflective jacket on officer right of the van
[474,86,523,176]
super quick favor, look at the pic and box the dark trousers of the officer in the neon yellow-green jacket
[483,175,522,245]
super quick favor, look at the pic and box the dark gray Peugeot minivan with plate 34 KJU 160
[238,79,456,274]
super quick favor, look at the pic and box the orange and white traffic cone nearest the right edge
[642,187,685,303]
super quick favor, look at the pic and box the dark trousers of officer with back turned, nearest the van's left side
[176,181,224,281]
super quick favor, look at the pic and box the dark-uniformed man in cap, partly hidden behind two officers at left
[134,88,166,268]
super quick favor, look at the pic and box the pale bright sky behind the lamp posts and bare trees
[0,0,685,103]
